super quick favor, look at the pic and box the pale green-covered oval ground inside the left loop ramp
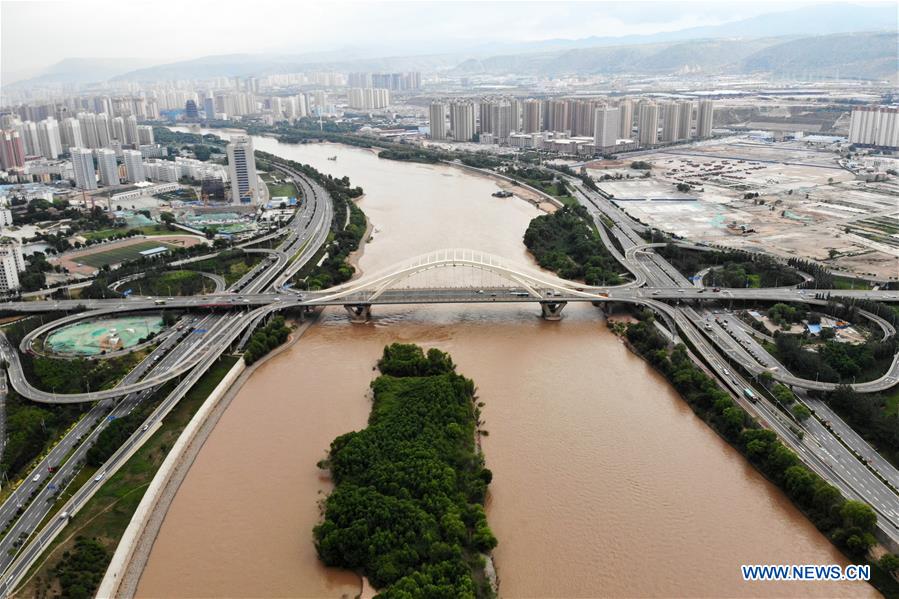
[44,315,163,356]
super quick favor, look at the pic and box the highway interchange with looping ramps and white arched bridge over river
[0,157,899,596]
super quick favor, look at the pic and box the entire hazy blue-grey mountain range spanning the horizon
[6,4,899,88]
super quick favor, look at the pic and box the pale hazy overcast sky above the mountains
[0,0,884,81]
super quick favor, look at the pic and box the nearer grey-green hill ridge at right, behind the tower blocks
[452,32,899,81]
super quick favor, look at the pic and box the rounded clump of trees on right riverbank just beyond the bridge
[524,206,621,285]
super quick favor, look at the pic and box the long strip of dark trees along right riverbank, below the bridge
[626,317,877,559]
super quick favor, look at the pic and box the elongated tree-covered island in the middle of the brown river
[314,344,496,599]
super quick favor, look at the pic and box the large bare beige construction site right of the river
[586,136,899,280]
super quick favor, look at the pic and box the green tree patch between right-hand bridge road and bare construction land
[656,243,802,287]
